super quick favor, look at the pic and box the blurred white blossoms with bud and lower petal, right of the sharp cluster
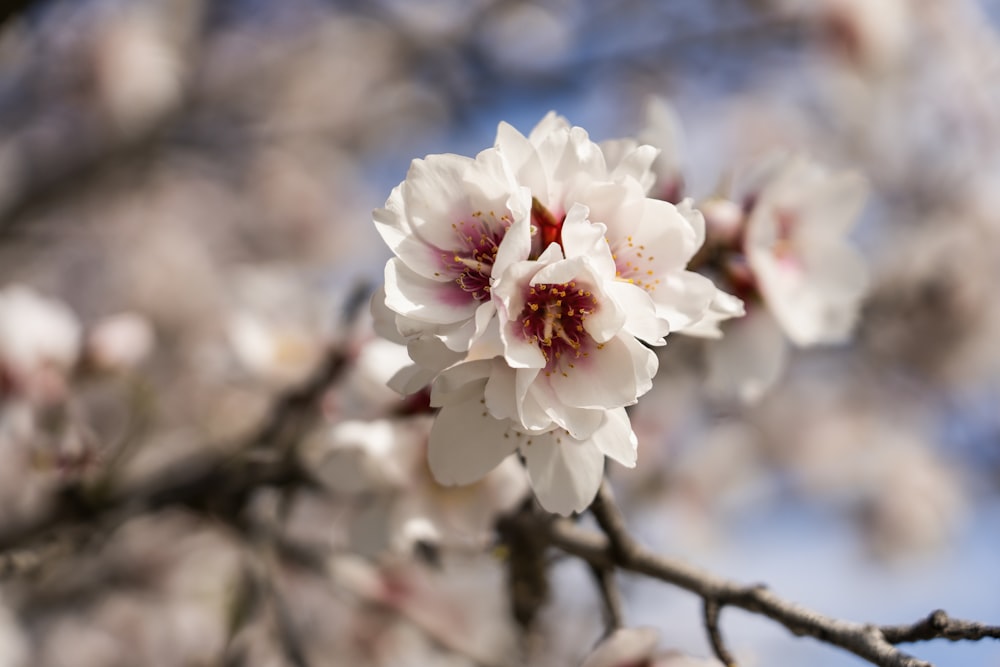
[704,156,869,401]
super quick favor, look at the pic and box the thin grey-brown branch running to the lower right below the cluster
[538,487,1000,667]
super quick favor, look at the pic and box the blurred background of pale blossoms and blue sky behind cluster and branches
[0,0,1000,667]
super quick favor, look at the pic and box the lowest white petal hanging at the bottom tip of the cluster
[518,430,604,516]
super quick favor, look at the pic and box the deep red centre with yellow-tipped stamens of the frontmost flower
[521,282,597,369]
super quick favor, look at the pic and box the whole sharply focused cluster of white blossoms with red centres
[373,113,740,514]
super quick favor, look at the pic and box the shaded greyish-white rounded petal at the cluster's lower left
[427,394,517,485]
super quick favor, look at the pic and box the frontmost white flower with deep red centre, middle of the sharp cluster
[486,206,657,438]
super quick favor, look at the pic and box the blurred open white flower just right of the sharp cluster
[745,157,868,346]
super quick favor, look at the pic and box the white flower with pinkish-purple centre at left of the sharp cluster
[374,150,531,351]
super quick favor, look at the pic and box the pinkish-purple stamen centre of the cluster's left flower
[441,211,510,301]
